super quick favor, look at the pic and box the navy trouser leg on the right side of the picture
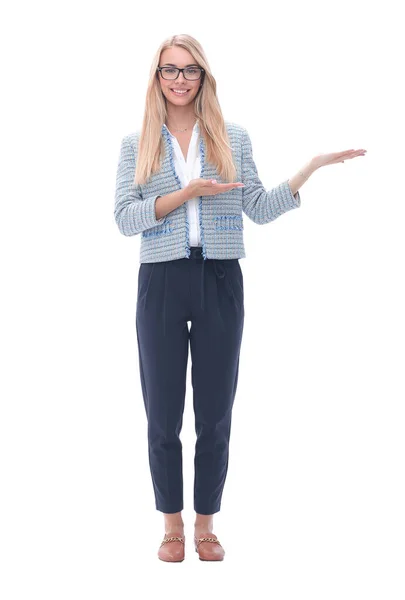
[190,255,244,514]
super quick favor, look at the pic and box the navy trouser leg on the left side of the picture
[136,261,189,513]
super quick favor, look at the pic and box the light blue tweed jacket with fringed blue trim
[114,121,301,263]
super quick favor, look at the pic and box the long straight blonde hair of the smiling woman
[134,34,236,184]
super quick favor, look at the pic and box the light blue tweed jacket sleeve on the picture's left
[114,136,165,235]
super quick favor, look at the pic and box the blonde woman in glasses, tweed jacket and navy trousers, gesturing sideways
[115,35,365,562]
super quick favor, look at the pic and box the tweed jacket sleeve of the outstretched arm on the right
[241,129,301,225]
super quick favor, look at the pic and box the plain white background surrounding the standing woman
[0,0,405,600]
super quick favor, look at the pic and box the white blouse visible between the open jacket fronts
[164,122,201,246]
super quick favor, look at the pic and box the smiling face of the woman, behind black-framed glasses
[158,46,203,106]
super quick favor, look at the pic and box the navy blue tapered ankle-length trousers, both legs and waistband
[136,246,245,515]
